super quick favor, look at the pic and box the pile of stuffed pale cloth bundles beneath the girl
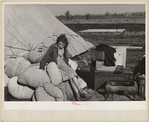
[4,44,102,101]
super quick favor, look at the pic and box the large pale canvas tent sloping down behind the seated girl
[4,4,93,60]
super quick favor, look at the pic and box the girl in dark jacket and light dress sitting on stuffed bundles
[40,34,89,100]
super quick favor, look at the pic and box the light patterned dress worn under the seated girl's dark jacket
[57,49,77,81]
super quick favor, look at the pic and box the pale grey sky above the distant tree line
[46,4,145,16]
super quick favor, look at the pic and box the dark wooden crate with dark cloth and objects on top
[89,61,133,90]
